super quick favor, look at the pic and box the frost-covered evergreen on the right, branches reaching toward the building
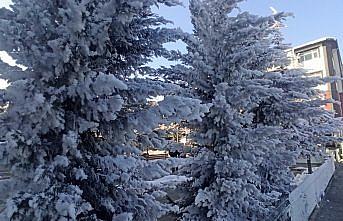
[170,0,343,221]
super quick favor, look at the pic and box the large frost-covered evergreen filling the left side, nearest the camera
[0,0,210,221]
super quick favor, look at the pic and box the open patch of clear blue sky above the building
[243,0,343,48]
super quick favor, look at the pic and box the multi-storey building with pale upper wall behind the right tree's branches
[287,37,343,117]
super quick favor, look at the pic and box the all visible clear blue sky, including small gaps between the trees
[0,0,343,68]
